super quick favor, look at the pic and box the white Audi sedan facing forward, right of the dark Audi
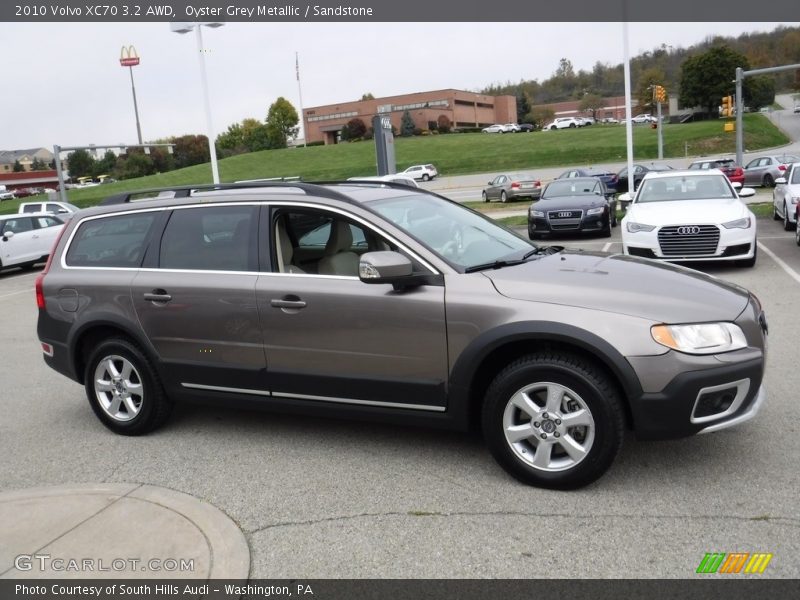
[619,169,757,267]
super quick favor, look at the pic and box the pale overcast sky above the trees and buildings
[0,23,798,150]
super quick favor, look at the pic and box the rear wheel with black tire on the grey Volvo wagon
[84,338,172,435]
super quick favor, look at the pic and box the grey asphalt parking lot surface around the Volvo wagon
[0,214,800,578]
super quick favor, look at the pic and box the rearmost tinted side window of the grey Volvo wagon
[66,212,157,268]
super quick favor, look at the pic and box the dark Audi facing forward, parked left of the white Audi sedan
[528,177,617,240]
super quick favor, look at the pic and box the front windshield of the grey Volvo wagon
[369,194,536,269]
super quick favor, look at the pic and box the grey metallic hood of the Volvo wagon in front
[482,250,750,323]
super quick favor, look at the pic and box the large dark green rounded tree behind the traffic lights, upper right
[678,45,750,113]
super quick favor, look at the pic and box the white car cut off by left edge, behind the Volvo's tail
[0,214,64,269]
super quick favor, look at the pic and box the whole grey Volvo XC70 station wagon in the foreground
[36,182,767,489]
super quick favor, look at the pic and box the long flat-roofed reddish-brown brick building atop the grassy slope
[303,89,517,144]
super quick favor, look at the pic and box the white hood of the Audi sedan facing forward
[625,198,749,226]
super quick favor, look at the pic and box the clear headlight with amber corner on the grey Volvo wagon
[650,323,747,354]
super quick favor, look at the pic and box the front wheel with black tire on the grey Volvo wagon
[482,351,625,490]
